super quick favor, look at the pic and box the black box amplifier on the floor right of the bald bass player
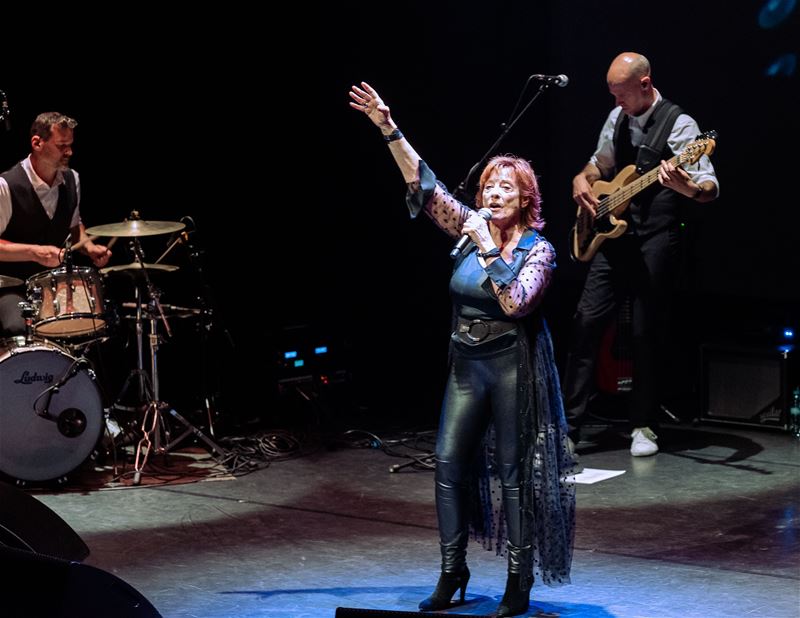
[700,345,797,430]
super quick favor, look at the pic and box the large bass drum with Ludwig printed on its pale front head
[0,337,103,484]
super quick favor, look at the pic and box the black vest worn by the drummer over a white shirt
[0,163,78,279]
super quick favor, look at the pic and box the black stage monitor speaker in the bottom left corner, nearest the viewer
[0,547,162,618]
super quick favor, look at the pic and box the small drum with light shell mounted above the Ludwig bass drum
[28,266,106,338]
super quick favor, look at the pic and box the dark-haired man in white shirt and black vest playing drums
[0,112,111,337]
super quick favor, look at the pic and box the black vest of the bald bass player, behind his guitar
[614,99,683,237]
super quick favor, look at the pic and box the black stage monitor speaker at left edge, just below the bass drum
[0,482,89,562]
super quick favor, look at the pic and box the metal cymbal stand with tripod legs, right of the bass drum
[125,237,227,485]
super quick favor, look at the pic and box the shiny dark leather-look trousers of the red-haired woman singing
[435,331,522,573]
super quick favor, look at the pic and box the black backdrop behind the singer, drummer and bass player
[0,1,800,424]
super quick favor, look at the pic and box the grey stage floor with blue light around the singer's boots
[25,418,800,618]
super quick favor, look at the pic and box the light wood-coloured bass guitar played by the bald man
[569,131,717,262]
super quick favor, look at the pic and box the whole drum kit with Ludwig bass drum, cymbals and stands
[0,211,226,485]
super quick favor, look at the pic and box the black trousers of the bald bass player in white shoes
[562,230,679,439]
